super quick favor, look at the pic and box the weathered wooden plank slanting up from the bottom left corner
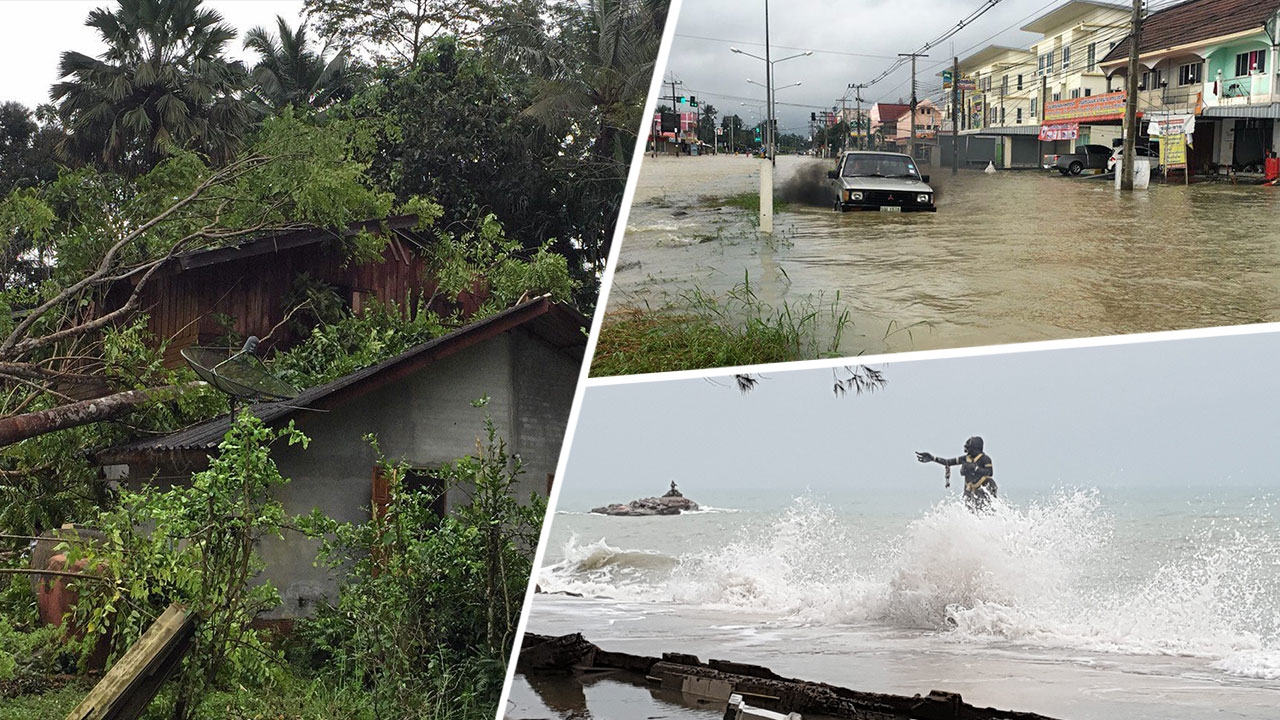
[67,605,196,720]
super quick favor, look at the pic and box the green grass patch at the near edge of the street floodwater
[591,275,850,377]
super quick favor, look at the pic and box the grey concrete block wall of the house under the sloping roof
[243,329,579,619]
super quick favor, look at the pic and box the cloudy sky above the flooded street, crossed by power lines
[663,0,1062,135]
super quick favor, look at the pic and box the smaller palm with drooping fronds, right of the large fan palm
[244,17,356,113]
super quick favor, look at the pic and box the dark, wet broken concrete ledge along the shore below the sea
[516,633,1052,720]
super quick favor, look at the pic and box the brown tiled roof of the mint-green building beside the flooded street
[1101,0,1280,63]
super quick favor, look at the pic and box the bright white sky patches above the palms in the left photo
[0,0,302,109]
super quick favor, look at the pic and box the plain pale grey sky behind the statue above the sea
[558,332,1280,510]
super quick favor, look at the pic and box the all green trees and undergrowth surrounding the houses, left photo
[0,0,667,719]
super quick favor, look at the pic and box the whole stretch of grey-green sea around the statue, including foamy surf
[513,487,1280,719]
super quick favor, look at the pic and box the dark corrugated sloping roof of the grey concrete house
[97,297,589,465]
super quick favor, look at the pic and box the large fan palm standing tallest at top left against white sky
[50,0,250,176]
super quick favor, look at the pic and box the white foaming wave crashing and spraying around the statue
[541,492,1280,680]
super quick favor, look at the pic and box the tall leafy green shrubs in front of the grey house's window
[298,419,545,717]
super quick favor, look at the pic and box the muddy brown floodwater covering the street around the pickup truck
[609,155,1280,355]
